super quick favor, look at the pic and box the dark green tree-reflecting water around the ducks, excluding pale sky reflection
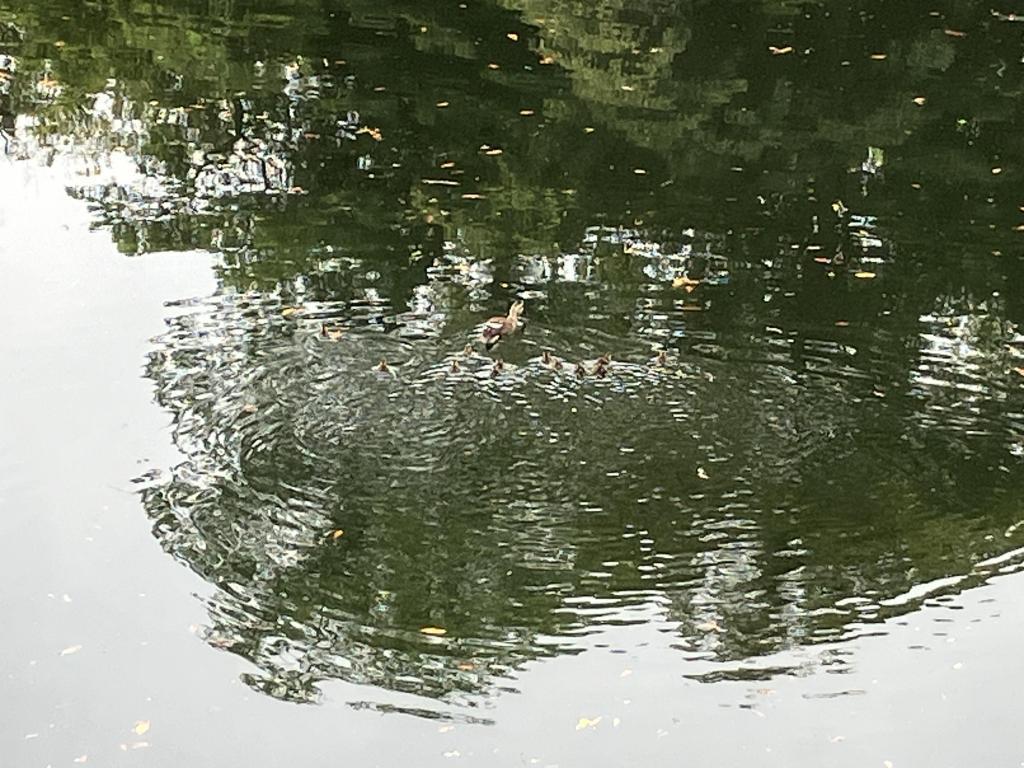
[0,0,1024,753]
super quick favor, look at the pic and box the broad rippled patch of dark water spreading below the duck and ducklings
[144,280,1020,701]
